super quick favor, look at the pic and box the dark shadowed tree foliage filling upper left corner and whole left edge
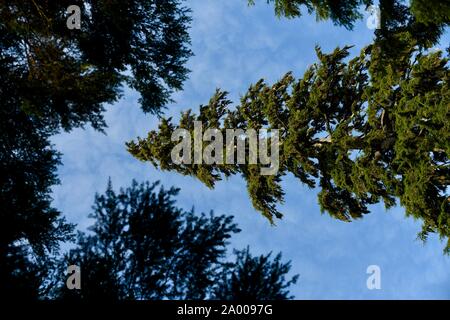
[0,0,191,298]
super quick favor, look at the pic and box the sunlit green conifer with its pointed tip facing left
[128,0,450,252]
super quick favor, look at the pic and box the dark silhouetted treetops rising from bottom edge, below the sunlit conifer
[52,182,297,300]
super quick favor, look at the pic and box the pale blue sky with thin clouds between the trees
[53,0,450,299]
